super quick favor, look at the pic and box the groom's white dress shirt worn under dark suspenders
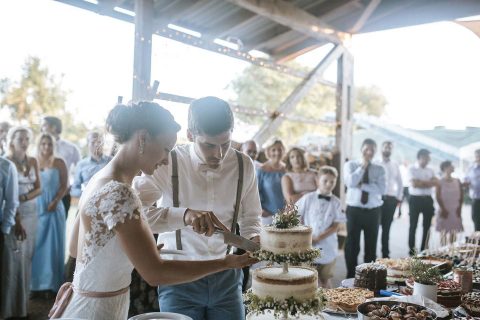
[133,144,262,260]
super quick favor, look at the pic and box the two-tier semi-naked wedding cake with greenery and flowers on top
[245,205,324,320]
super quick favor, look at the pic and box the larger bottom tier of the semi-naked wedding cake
[252,267,318,301]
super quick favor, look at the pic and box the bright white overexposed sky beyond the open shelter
[0,0,480,139]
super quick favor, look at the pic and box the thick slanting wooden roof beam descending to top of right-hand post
[228,0,343,44]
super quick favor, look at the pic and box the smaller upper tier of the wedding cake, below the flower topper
[260,226,312,254]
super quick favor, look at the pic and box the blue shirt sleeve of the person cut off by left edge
[0,165,20,234]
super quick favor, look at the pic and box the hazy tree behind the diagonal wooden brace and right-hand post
[229,64,386,144]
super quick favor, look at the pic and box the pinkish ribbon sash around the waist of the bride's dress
[48,282,130,319]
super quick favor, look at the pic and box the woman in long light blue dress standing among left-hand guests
[31,134,68,292]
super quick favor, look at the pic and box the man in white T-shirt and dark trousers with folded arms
[408,149,438,255]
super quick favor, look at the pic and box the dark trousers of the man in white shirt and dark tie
[345,206,381,278]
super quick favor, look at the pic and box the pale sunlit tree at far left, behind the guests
[0,57,87,146]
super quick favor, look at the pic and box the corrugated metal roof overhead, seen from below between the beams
[57,0,480,62]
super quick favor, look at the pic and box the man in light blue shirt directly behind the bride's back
[70,131,112,198]
